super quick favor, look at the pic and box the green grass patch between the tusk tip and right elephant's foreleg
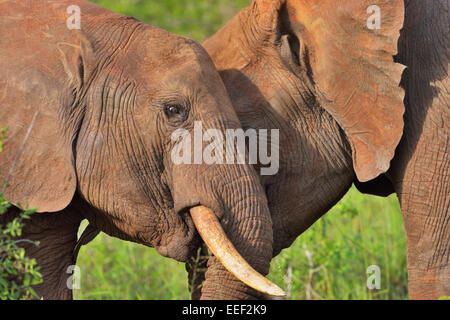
[270,188,408,300]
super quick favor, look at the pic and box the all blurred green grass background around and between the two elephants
[74,0,408,299]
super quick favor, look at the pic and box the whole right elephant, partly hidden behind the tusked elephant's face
[192,0,450,299]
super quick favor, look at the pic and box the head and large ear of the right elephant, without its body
[203,0,404,254]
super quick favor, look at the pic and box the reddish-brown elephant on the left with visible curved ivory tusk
[0,0,283,299]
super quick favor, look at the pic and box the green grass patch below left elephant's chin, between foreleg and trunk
[74,233,189,300]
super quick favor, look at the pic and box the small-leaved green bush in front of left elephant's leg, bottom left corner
[0,129,42,300]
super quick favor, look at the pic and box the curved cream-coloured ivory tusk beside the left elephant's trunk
[190,206,286,297]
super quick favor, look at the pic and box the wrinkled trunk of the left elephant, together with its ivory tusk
[173,164,284,300]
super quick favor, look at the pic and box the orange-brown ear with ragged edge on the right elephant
[284,0,404,182]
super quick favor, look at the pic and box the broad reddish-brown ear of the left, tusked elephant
[0,21,93,212]
